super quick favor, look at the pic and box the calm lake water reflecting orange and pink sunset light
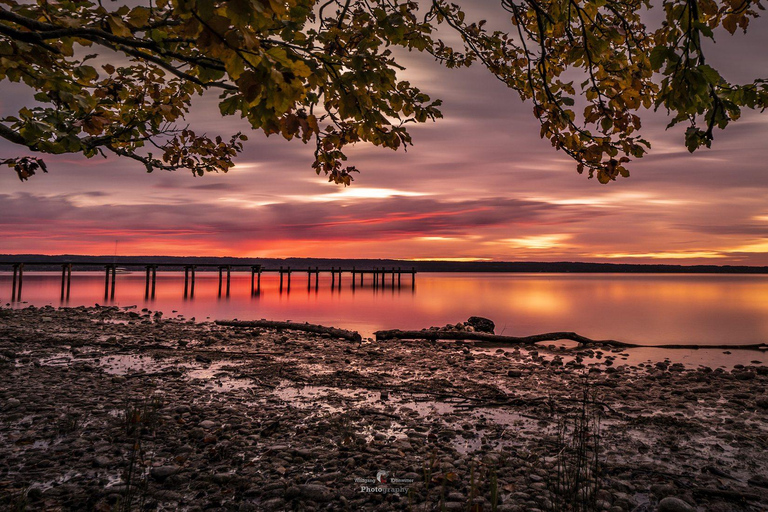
[0,270,768,344]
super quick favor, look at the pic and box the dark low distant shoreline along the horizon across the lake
[0,254,768,274]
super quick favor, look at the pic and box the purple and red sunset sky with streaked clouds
[0,0,768,265]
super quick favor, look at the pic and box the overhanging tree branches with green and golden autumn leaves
[0,0,768,185]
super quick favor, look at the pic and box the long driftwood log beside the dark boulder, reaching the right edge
[374,329,768,351]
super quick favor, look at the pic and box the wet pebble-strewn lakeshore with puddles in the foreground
[0,307,768,512]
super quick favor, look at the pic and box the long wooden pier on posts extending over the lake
[0,261,416,302]
